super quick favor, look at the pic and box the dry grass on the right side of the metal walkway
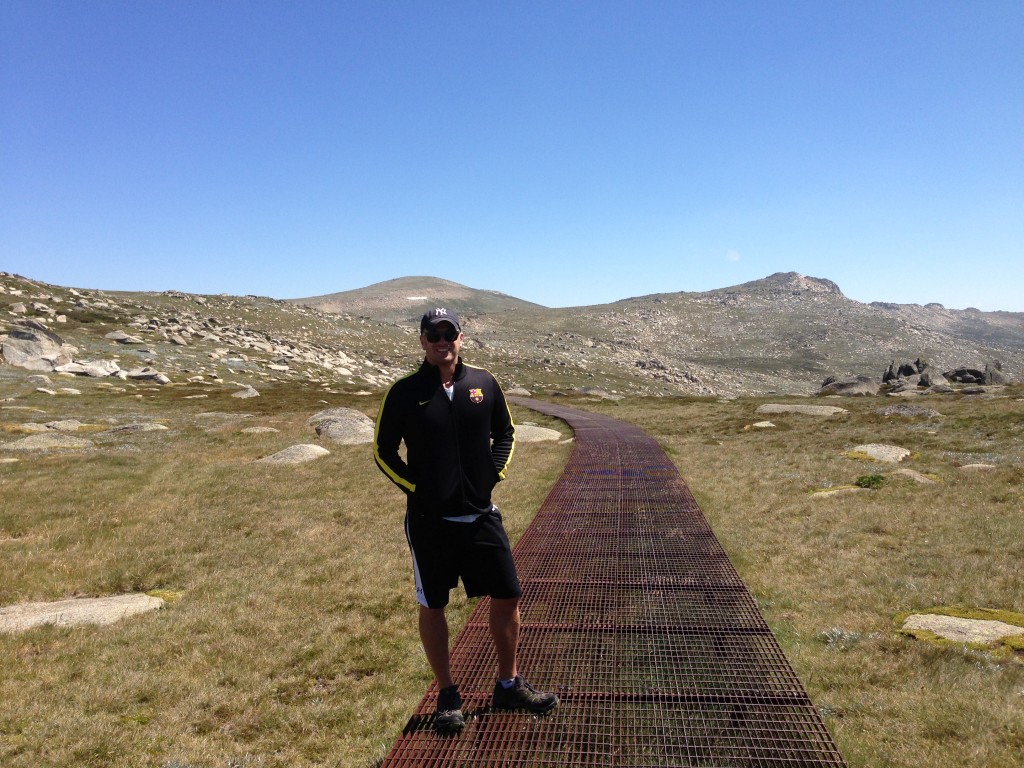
[582,389,1024,768]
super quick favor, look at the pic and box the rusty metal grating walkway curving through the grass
[381,398,846,768]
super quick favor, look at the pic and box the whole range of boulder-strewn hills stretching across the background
[0,272,1024,397]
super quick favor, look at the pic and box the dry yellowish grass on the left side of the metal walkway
[0,389,568,766]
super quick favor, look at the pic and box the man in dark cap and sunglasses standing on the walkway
[374,308,558,732]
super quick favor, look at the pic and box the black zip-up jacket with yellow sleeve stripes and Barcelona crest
[374,357,515,517]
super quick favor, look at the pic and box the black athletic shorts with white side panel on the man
[406,507,522,608]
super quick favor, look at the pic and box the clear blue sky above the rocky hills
[0,0,1024,311]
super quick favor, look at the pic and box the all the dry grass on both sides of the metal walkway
[0,379,1024,768]
